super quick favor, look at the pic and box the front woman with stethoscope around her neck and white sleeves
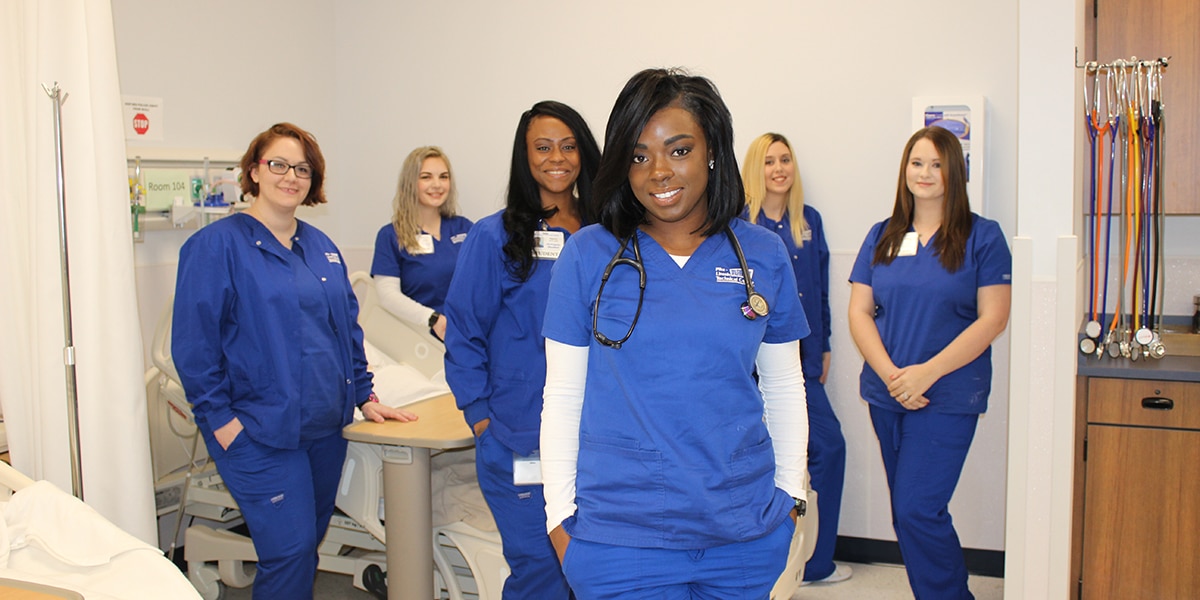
[541,70,808,599]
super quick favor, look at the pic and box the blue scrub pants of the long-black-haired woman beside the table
[475,428,571,600]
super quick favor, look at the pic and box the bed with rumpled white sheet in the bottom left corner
[0,462,199,600]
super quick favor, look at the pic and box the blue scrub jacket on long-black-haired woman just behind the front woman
[443,210,570,455]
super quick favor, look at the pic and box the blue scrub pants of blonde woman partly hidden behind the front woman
[804,374,846,581]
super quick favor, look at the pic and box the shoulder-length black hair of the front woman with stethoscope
[595,68,745,239]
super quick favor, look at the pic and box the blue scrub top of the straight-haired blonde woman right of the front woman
[742,205,833,379]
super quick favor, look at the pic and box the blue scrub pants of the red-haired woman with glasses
[205,430,346,600]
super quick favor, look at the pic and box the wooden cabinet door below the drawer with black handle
[1081,425,1200,600]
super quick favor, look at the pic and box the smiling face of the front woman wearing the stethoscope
[629,106,709,234]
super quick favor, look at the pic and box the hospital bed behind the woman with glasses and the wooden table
[146,272,508,600]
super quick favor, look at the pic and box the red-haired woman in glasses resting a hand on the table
[172,122,416,599]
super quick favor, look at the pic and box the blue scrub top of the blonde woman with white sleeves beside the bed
[371,216,470,312]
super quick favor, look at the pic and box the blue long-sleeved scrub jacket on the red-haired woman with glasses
[172,214,372,449]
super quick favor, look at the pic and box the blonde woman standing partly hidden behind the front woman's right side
[742,133,852,583]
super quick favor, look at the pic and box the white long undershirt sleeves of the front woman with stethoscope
[541,338,809,533]
